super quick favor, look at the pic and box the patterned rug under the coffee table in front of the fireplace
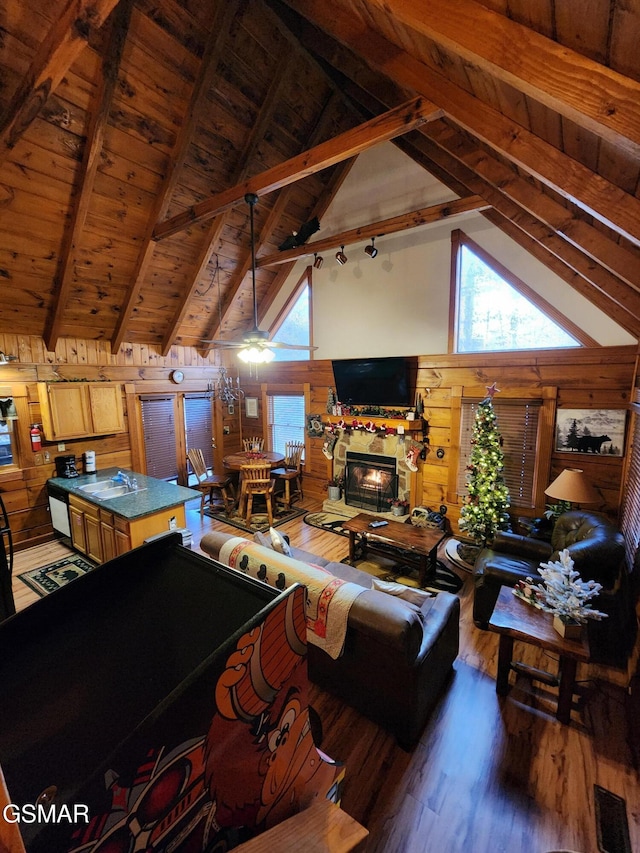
[304,512,463,593]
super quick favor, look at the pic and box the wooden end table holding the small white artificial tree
[489,586,589,724]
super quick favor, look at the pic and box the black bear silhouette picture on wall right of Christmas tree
[555,409,627,456]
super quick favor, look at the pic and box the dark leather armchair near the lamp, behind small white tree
[473,510,635,664]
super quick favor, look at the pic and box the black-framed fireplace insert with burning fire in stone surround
[344,451,398,512]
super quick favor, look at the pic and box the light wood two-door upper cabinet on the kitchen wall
[38,382,125,441]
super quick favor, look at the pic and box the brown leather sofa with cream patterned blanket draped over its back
[200,531,460,749]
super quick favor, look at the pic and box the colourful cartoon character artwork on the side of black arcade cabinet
[67,587,344,853]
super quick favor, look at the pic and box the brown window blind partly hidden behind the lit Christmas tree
[458,400,542,507]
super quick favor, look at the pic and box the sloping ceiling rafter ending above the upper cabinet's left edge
[43,0,134,352]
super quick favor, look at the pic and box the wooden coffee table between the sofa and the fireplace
[342,512,446,586]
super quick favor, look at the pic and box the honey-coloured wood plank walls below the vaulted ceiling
[0,335,637,547]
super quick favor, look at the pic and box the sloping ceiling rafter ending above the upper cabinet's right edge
[111,0,239,355]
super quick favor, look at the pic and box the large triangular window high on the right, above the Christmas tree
[452,231,585,352]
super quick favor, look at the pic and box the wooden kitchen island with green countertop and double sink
[47,468,200,563]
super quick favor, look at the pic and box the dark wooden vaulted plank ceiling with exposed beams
[0,0,640,353]
